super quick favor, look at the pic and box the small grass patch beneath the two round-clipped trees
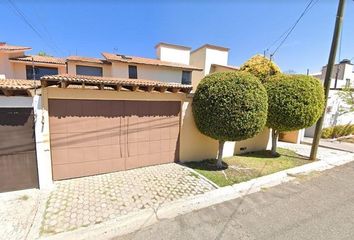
[185,148,310,187]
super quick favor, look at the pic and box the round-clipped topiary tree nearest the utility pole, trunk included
[264,74,325,155]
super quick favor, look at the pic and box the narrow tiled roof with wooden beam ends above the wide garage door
[41,74,192,93]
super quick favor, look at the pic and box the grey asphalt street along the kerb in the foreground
[114,159,354,240]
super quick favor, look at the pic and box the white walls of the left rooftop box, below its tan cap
[156,46,190,65]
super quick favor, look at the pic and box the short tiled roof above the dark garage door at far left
[0,79,41,96]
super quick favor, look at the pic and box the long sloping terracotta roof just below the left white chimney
[102,53,203,71]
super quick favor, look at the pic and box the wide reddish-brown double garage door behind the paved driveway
[49,99,180,180]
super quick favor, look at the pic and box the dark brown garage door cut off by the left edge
[0,108,38,192]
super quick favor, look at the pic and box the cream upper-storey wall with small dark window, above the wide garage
[112,62,182,83]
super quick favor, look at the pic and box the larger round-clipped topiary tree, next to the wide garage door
[192,71,268,168]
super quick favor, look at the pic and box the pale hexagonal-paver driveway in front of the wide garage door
[41,164,214,236]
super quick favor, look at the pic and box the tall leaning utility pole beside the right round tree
[310,0,345,160]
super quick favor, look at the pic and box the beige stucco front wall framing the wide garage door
[42,87,269,165]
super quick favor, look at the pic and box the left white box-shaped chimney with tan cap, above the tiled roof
[155,42,191,65]
